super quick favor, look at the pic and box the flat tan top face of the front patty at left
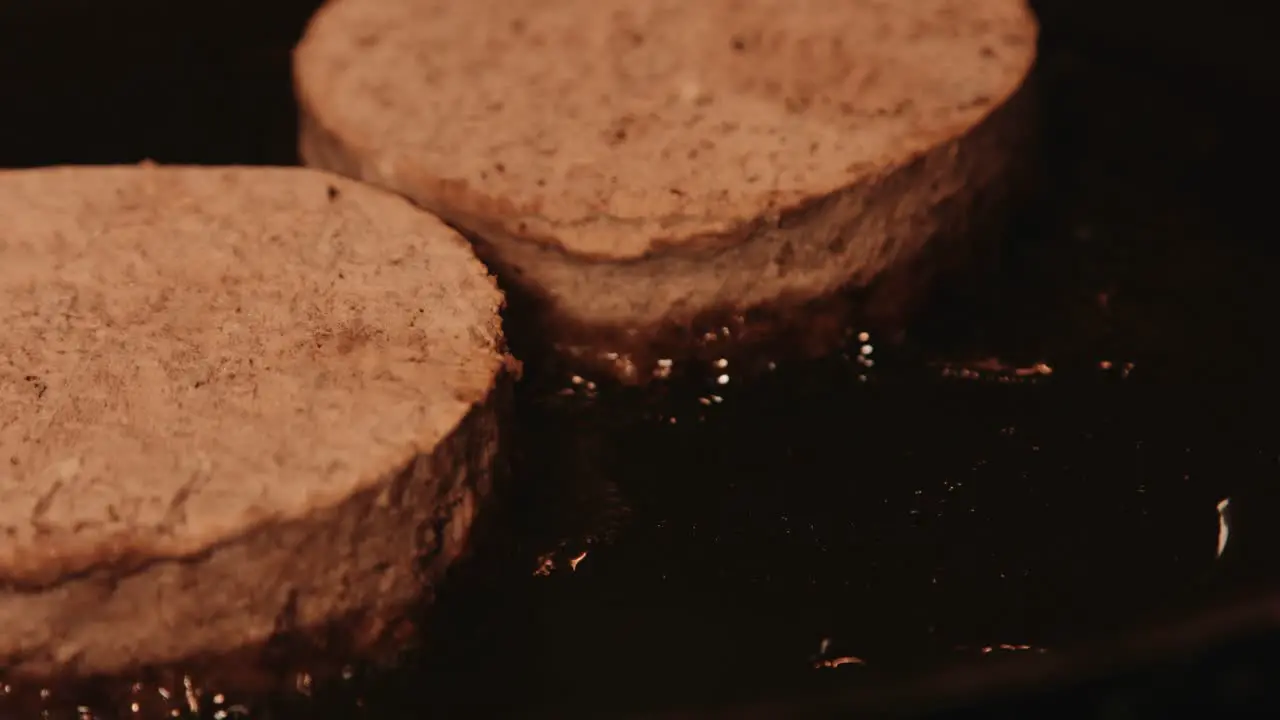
[0,167,502,585]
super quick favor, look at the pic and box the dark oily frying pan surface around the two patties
[0,4,1280,720]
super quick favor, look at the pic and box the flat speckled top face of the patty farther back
[296,0,1037,260]
